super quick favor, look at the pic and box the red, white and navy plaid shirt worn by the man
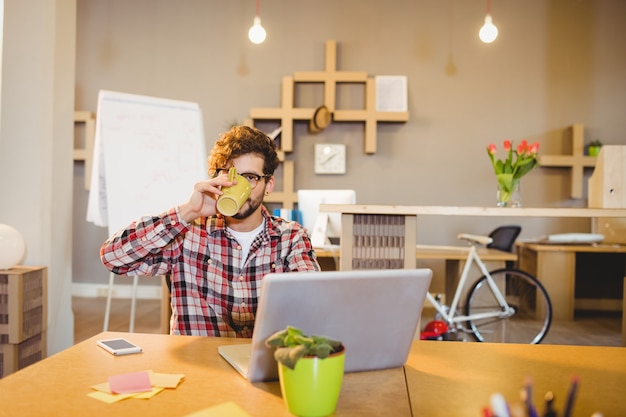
[100,207,320,337]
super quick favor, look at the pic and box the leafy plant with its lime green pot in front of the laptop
[265,326,345,417]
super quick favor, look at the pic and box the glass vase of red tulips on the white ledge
[487,140,539,207]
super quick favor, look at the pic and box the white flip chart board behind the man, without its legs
[87,90,208,235]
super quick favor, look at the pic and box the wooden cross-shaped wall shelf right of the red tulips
[539,124,596,198]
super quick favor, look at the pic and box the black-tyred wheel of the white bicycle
[465,268,552,343]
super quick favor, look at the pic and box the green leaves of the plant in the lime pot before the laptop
[265,326,343,369]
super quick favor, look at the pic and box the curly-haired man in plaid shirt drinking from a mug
[100,126,320,337]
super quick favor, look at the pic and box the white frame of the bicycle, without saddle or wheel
[426,243,515,324]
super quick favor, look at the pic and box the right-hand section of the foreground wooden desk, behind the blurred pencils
[405,341,626,417]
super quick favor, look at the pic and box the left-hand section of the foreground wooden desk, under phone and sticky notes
[0,332,411,417]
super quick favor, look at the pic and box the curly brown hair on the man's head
[209,126,279,176]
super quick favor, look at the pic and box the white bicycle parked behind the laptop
[426,233,552,344]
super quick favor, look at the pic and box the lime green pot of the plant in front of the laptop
[278,349,346,417]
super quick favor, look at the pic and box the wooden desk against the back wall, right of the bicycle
[517,242,626,320]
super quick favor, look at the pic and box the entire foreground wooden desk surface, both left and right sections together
[0,332,626,417]
